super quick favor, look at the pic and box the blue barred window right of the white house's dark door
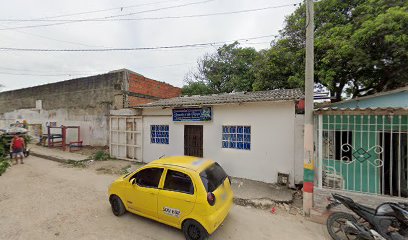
[222,126,251,150]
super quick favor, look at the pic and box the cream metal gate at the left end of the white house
[109,116,143,162]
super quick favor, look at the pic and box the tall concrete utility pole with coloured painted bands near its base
[303,0,314,216]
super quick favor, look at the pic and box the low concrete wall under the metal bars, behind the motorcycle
[313,188,408,211]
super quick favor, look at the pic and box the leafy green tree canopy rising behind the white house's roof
[183,0,408,101]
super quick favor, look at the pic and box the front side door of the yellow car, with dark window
[126,167,164,219]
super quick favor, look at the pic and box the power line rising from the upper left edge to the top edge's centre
[0,0,215,31]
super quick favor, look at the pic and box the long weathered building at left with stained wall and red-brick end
[0,69,181,145]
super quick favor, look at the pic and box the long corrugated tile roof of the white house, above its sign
[136,89,304,108]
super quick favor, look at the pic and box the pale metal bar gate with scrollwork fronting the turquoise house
[315,109,408,197]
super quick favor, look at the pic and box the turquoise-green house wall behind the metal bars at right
[322,115,408,193]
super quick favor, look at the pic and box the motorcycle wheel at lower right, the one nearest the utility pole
[326,212,358,240]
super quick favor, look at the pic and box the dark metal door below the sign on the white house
[184,125,203,157]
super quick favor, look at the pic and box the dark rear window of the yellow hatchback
[200,163,227,192]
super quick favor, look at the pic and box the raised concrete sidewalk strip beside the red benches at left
[28,144,89,162]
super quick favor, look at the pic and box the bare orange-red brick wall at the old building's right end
[129,73,181,106]
